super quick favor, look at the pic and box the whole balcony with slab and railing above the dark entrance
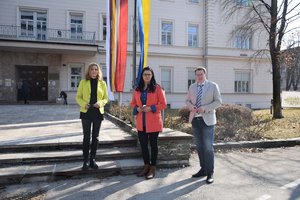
[0,25,98,56]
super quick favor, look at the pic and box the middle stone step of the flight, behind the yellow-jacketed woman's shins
[0,147,141,166]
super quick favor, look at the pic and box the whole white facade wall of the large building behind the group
[0,0,272,108]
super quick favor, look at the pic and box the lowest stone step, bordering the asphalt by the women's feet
[0,158,186,186]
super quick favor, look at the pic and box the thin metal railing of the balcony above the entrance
[0,25,96,44]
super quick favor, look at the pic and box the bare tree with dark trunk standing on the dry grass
[222,0,300,119]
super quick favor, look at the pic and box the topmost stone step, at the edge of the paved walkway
[0,137,137,153]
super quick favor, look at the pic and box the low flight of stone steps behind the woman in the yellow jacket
[0,137,143,185]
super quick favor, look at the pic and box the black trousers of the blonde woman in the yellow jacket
[81,119,102,162]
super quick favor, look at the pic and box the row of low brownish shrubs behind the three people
[108,104,272,142]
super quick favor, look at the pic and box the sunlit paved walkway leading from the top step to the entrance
[0,105,131,146]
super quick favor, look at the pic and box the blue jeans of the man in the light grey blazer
[192,117,215,174]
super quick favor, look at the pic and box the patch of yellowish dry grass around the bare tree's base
[254,109,300,139]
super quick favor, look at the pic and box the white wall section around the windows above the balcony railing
[0,0,106,39]
